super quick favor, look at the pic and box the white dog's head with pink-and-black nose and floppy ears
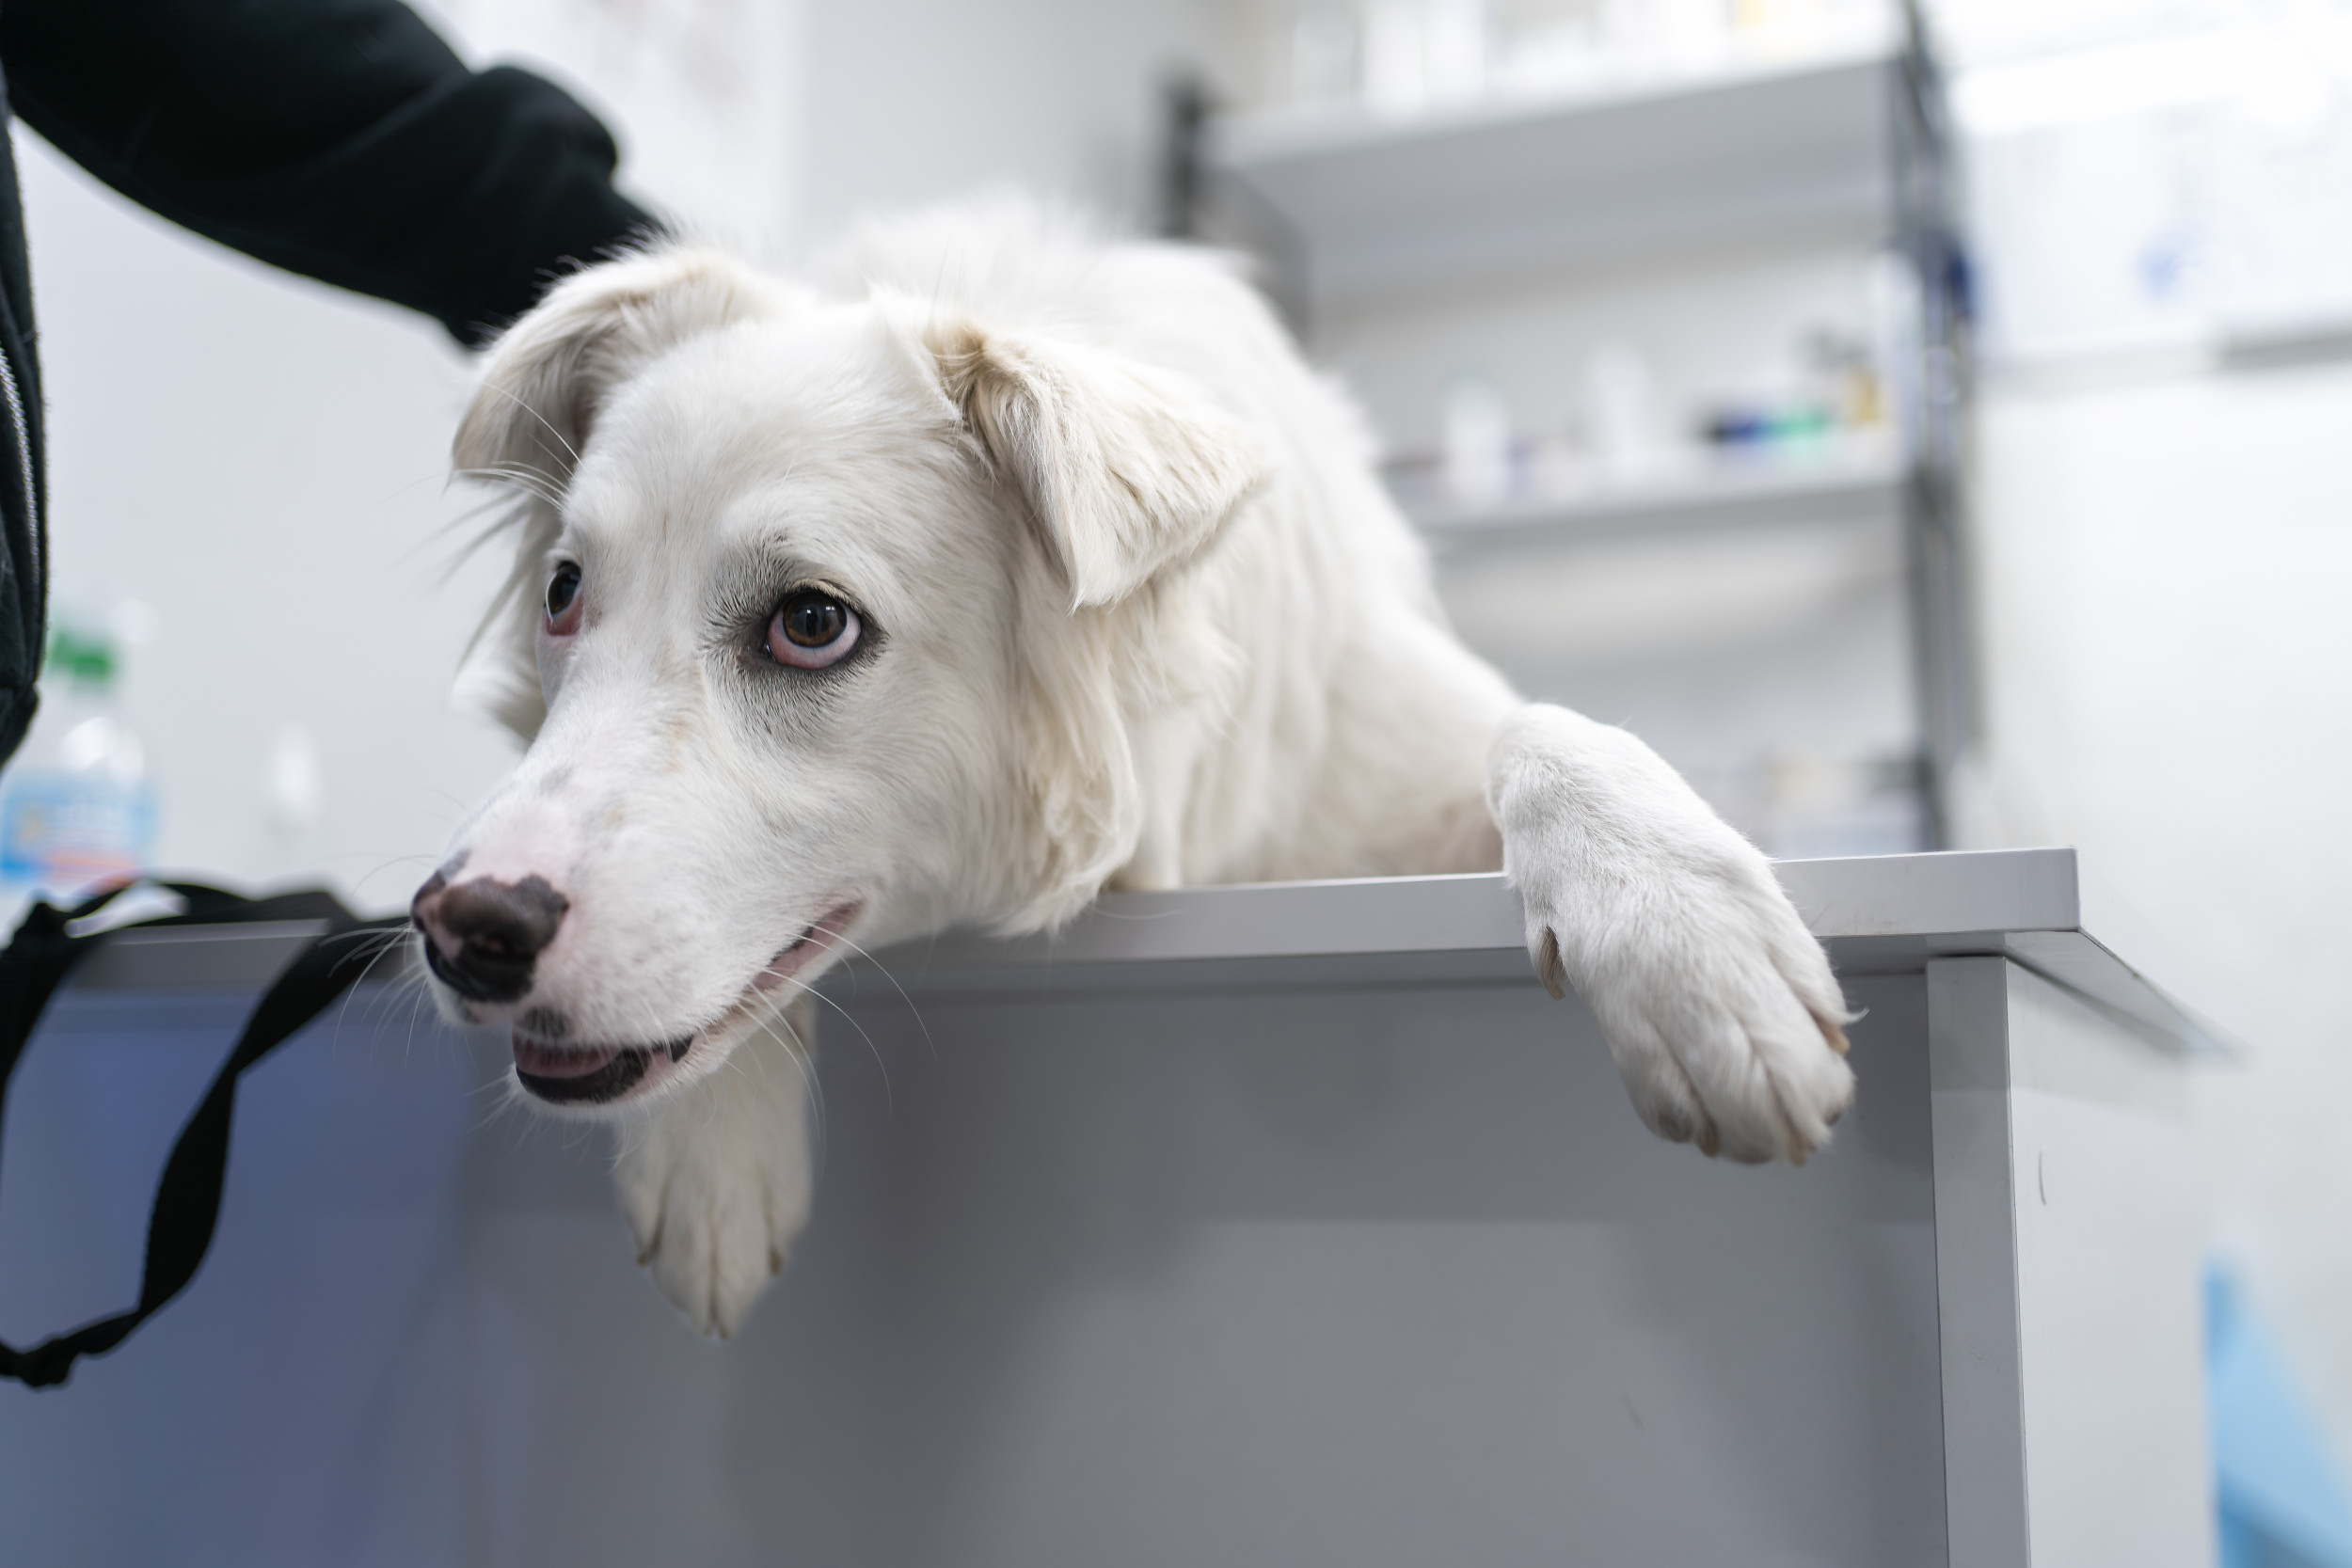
[414,249,1256,1107]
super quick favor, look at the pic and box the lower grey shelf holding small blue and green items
[1391,442,1905,550]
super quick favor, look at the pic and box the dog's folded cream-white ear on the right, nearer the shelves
[925,320,1263,609]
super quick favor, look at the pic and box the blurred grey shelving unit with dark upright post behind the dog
[1167,0,1979,847]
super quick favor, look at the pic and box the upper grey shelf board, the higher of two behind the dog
[1207,28,1900,292]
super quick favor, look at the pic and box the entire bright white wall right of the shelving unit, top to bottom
[1936,0,2352,1463]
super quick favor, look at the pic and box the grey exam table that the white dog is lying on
[0,848,2218,1568]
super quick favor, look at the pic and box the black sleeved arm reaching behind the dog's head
[0,0,654,345]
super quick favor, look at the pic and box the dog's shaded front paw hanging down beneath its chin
[614,1004,814,1338]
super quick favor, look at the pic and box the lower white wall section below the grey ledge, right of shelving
[1976,367,2352,1455]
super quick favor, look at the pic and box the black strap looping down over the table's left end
[0,881,409,1389]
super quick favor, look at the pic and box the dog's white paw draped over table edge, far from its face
[1489,705,1853,1164]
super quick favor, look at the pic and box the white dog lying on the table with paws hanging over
[414,209,1853,1336]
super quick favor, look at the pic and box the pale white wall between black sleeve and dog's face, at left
[17,129,511,908]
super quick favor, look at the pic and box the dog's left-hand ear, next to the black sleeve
[454,246,786,491]
